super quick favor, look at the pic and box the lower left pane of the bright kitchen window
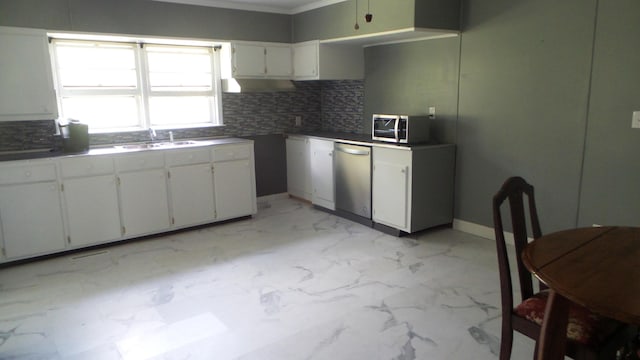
[62,96,140,131]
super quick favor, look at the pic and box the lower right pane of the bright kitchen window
[149,96,211,126]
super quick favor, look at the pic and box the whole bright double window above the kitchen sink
[52,39,222,132]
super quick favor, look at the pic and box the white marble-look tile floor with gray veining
[0,196,534,360]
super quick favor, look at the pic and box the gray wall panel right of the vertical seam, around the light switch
[579,0,640,226]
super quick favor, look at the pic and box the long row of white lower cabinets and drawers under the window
[0,139,257,262]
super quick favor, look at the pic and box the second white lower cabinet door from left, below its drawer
[63,175,122,246]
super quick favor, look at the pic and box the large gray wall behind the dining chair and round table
[455,0,640,232]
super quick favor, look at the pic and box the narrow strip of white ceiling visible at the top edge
[154,0,346,15]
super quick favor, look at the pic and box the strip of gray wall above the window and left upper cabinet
[0,0,291,42]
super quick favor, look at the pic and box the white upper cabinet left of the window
[0,26,58,121]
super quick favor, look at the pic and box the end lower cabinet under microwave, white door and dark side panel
[372,144,455,233]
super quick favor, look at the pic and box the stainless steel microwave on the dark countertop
[371,114,429,144]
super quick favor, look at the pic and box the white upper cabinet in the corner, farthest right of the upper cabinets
[293,40,364,80]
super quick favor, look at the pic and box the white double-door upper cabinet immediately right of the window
[222,43,293,79]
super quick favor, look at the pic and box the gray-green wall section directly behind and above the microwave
[364,37,460,143]
